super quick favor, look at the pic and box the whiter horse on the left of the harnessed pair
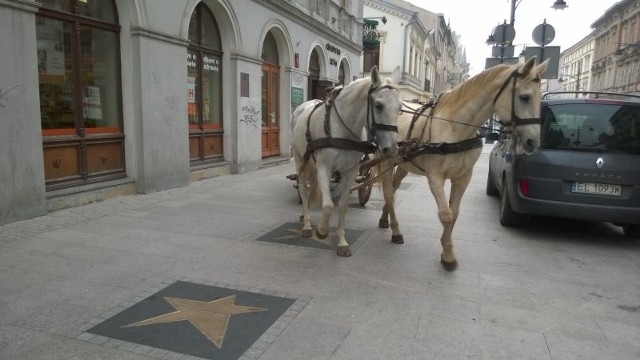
[291,67,401,256]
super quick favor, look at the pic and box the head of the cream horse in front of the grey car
[493,58,549,155]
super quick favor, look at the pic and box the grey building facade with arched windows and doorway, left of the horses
[0,0,363,225]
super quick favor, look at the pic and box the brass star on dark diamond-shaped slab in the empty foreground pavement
[87,281,295,359]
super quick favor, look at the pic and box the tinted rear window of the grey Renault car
[540,103,640,154]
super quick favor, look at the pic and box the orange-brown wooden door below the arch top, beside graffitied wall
[262,64,280,157]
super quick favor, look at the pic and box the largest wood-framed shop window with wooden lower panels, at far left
[36,0,125,190]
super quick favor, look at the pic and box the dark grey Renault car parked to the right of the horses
[486,91,640,238]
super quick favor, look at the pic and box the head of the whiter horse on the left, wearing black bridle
[367,66,402,157]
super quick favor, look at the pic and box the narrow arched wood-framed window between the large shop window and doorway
[186,3,224,165]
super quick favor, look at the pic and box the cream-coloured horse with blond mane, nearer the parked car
[377,58,548,270]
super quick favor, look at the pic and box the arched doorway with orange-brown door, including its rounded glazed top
[262,32,280,158]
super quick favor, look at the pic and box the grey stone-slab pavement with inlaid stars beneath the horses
[0,145,640,360]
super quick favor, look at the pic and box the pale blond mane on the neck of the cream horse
[438,64,511,108]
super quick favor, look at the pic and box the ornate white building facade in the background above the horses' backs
[362,0,469,102]
